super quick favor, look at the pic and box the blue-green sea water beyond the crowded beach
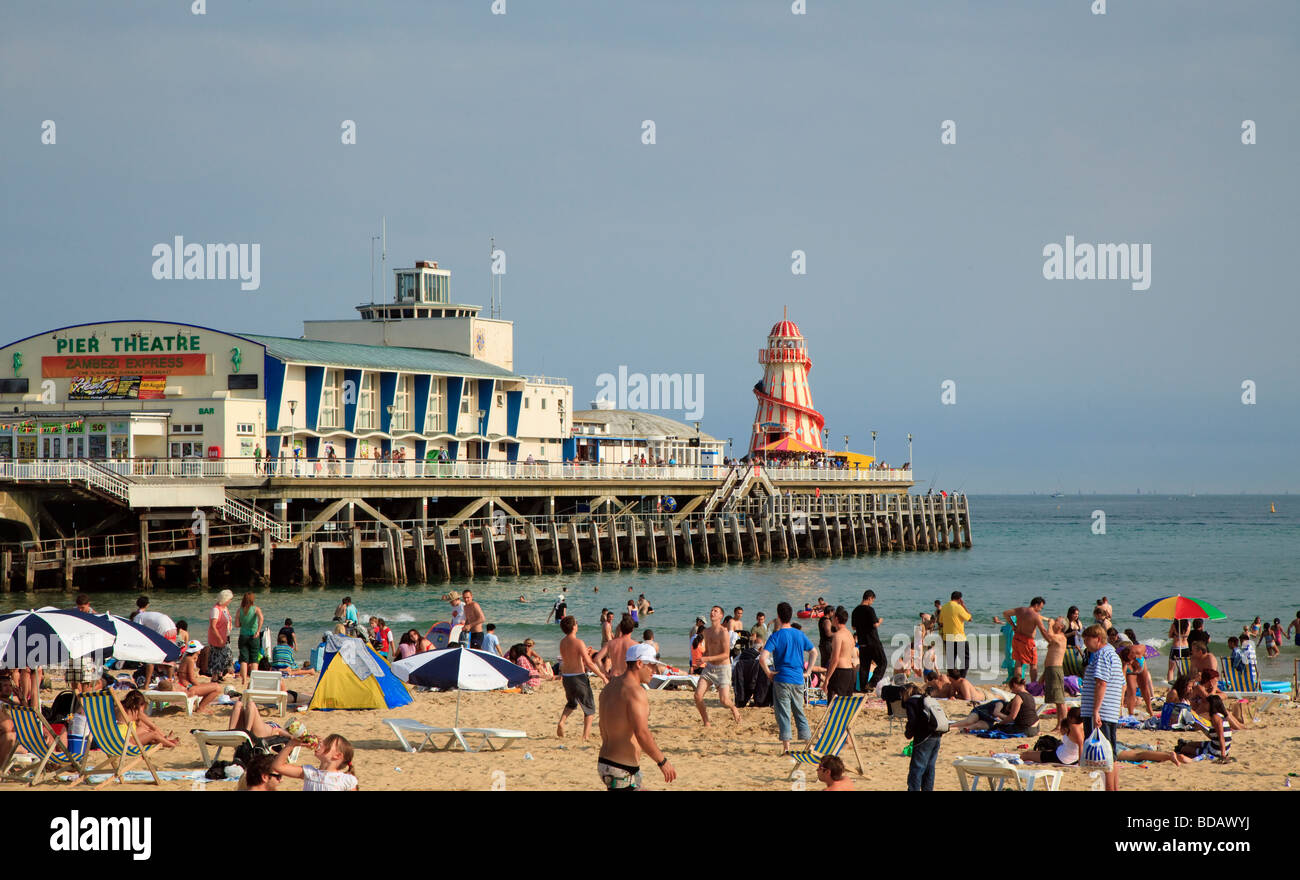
[0,494,1300,680]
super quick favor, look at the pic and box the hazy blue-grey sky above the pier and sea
[0,0,1300,494]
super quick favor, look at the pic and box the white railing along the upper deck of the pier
[0,458,913,483]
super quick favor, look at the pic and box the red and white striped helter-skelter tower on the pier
[749,309,826,454]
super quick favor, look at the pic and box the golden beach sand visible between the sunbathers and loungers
[17,676,1300,792]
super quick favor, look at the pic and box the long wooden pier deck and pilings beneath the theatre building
[0,459,971,591]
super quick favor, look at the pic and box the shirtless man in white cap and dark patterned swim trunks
[595,645,677,792]
